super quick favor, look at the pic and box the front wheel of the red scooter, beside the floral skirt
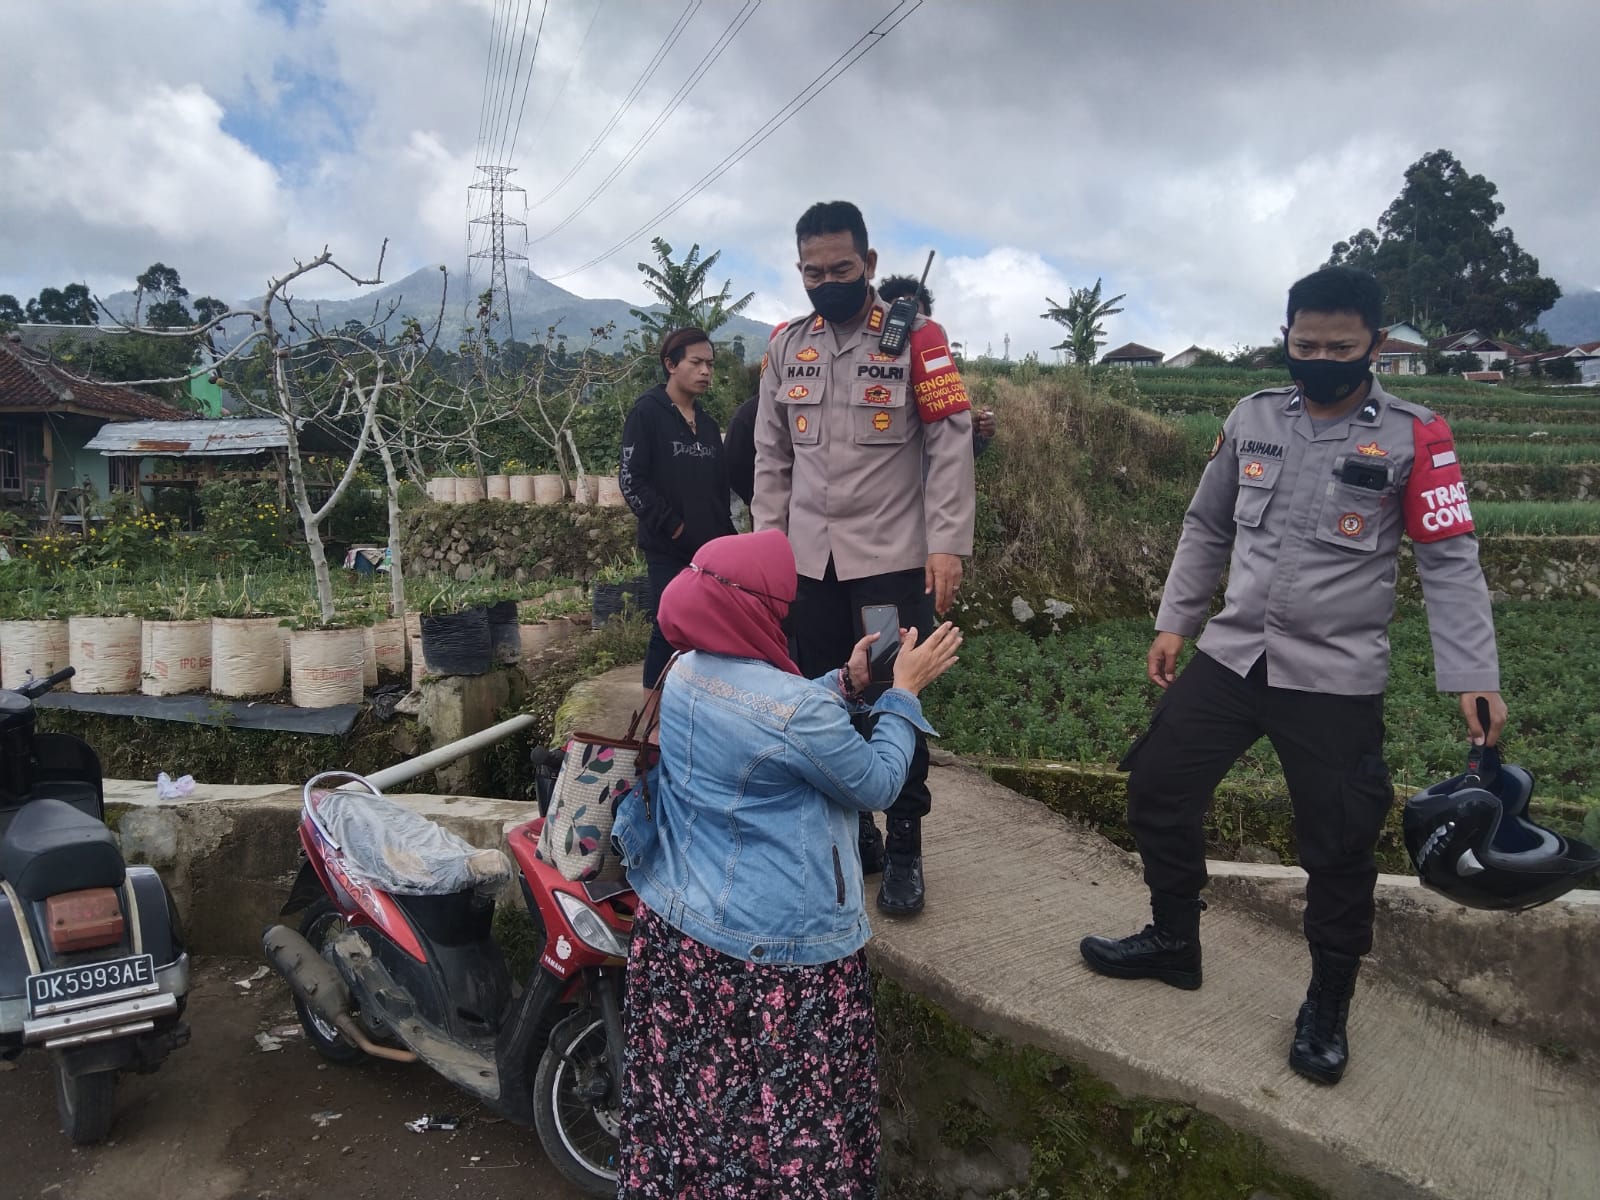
[533,1008,619,1197]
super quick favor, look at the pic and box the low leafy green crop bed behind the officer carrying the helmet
[925,600,1600,805]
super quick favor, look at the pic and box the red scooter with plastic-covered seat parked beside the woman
[262,750,637,1195]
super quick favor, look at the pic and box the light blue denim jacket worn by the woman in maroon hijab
[611,651,933,965]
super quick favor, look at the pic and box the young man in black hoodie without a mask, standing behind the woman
[618,330,734,688]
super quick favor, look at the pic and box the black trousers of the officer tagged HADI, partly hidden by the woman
[789,558,934,818]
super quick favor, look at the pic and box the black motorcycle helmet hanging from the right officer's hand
[1403,746,1600,909]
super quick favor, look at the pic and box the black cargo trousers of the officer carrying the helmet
[1122,653,1394,955]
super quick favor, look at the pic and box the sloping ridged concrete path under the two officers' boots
[569,666,1600,1200]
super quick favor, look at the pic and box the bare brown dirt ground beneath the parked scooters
[9,958,579,1200]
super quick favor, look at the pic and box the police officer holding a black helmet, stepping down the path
[1082,267,1506,1083]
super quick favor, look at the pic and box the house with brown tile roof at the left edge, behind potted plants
[0,334,194,509]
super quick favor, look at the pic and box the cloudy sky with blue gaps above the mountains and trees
[0,0,1600,357]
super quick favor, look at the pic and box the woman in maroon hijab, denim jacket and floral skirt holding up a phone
[613,530,962,1200]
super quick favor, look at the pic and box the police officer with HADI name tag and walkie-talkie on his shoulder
[750,200,974,915]
